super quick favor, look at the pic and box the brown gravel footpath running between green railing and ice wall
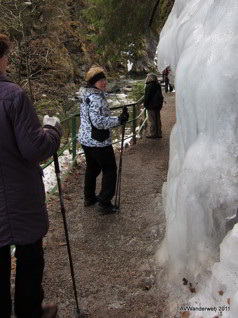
[44,93,175,318]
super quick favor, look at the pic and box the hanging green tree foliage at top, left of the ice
[83,0,174,66]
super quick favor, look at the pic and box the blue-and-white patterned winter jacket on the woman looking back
[78,87,120,147]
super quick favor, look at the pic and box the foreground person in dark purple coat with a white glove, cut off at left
[0,34,62,318]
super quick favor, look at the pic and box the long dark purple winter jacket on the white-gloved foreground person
[0,73,60,247]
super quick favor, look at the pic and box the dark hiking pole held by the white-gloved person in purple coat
[53,153,81,318]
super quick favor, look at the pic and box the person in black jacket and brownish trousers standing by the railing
[144,73,164,138]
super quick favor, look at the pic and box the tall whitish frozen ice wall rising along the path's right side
[158,0,238,279]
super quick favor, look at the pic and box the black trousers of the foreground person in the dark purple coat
[0,240,44,318]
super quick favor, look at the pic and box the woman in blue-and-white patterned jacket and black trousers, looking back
[79,66,129,214]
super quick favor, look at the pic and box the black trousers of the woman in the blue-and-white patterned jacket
[82,146,117,203]
